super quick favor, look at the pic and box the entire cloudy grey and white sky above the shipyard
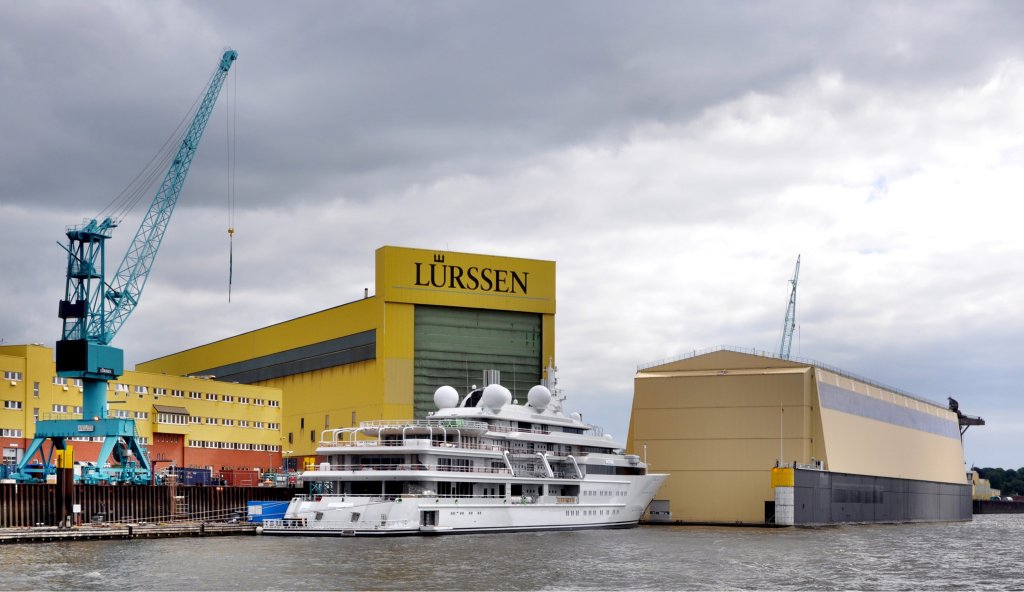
[0,0,1024,467]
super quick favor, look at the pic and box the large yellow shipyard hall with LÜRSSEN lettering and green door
[138,247,555,464]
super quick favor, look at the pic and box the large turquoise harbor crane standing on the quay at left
[13,49,239,483]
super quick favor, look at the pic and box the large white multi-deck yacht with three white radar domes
[263,367,667,536]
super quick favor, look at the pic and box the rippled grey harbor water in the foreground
[0,514,1024,590]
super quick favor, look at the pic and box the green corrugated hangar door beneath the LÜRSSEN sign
[413,305,543,419]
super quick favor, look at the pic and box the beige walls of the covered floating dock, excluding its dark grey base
[627,349,965,523]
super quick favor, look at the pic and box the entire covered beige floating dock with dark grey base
[627,348,971,524]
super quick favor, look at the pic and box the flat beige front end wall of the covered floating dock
[627,351,824,523]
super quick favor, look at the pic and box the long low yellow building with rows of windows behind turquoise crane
[0,344,282,473]
